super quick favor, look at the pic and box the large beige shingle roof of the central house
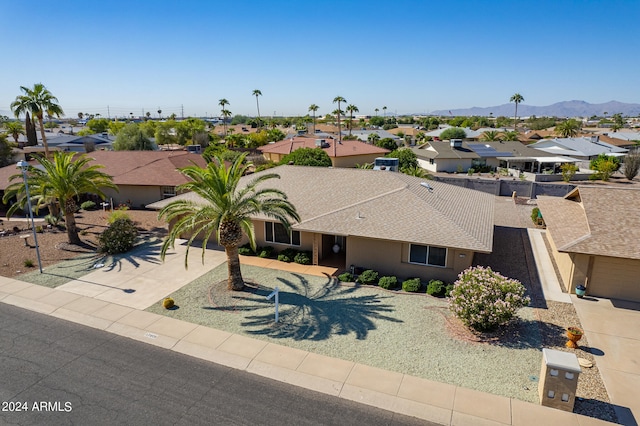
[149,166,494,252]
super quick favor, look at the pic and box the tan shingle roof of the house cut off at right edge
[538,186,640,259]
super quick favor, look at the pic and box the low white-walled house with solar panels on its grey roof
[411,140,578,173]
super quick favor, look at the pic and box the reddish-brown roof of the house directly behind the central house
[258,136,389,157]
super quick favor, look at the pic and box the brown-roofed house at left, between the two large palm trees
[0,151,206,208]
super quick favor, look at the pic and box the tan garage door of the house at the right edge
[588,256,640,302]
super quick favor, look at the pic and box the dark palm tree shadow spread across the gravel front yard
[208,274,402,341]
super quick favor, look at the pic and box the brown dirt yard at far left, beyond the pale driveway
[0,210,167,277]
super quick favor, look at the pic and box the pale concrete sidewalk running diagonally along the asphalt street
[0,277,608,426]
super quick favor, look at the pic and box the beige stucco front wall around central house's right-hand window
[346,237,473,282]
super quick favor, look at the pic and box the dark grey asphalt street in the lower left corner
[0,303,430,426]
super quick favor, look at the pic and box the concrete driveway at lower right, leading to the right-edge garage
[571,295,640,425]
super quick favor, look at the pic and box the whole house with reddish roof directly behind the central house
[258,136,389,167]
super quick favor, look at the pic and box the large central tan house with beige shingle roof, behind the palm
[147,166,494,282]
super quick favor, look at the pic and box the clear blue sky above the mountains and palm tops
[0,0,640,117]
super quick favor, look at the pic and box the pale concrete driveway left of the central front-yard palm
[58,240,227,309]
